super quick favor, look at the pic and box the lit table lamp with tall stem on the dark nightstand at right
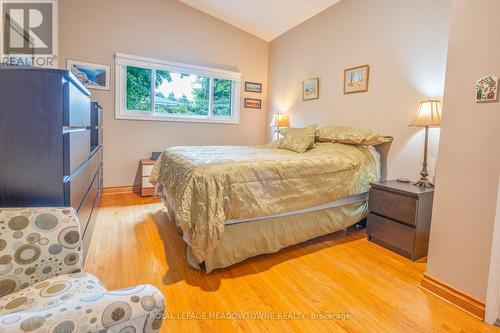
[410,100,441,187]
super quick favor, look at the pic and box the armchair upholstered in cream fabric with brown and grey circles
[0,208,164,333]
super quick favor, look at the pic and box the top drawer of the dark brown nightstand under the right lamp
[368,188,417,225]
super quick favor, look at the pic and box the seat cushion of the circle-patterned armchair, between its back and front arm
[0,273,107,316]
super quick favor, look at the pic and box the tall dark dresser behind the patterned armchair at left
[0,67,103,261]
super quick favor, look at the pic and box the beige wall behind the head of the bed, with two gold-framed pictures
[268,0,451,179]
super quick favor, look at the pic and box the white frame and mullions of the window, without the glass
[115,53,241,124]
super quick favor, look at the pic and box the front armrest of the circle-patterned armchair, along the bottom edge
[0,285,165,333]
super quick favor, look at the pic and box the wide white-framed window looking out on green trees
[115,54,241,124]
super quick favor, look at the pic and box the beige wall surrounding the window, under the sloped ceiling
[59,0,269,187]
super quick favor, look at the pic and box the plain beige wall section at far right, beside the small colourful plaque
[427,0,500,300]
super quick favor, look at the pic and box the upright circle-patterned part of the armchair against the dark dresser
[0,208,82,297]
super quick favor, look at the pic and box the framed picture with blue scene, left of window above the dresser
[66,60,110,90]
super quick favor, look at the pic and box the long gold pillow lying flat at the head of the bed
[316,126,392,146]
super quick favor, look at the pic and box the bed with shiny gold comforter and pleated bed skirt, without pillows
[151,142,380,272]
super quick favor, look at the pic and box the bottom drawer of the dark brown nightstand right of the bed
[366,213,416,257]
